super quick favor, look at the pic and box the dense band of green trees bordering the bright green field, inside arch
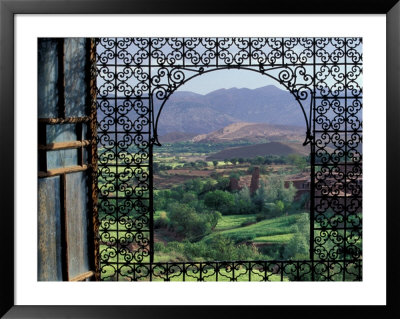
[154,175,298,241]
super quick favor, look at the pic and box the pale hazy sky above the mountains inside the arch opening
[175,70,284,94]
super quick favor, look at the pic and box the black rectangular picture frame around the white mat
[0,0,400,318]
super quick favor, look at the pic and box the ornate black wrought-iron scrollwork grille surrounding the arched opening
[96,38,362,281]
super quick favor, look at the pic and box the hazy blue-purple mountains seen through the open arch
[156,85,305,136]
